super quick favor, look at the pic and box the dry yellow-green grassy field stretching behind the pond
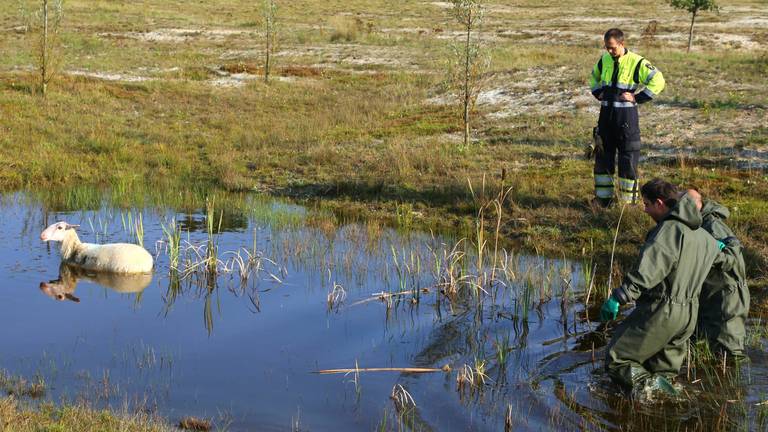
[0,0,768,277]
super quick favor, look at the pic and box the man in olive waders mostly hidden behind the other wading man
[687,189,749,359]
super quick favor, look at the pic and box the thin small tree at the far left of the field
[19,0,64,97]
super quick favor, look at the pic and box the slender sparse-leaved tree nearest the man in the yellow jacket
[448,0,489,147]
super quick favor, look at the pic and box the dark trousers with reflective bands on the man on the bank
[594,106,641,204]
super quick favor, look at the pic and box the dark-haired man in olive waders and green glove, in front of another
[600,179,740,390]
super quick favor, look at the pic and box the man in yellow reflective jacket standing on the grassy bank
[589,28,665,207]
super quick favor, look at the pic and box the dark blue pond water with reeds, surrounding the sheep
[0,195,768,431]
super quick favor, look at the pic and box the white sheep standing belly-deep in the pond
[40,222,153,273]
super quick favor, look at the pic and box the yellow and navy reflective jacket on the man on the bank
[589,48,666,106]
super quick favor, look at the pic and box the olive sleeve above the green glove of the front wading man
[611,241,677,304]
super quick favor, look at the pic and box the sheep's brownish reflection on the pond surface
[40,263,152,303]
